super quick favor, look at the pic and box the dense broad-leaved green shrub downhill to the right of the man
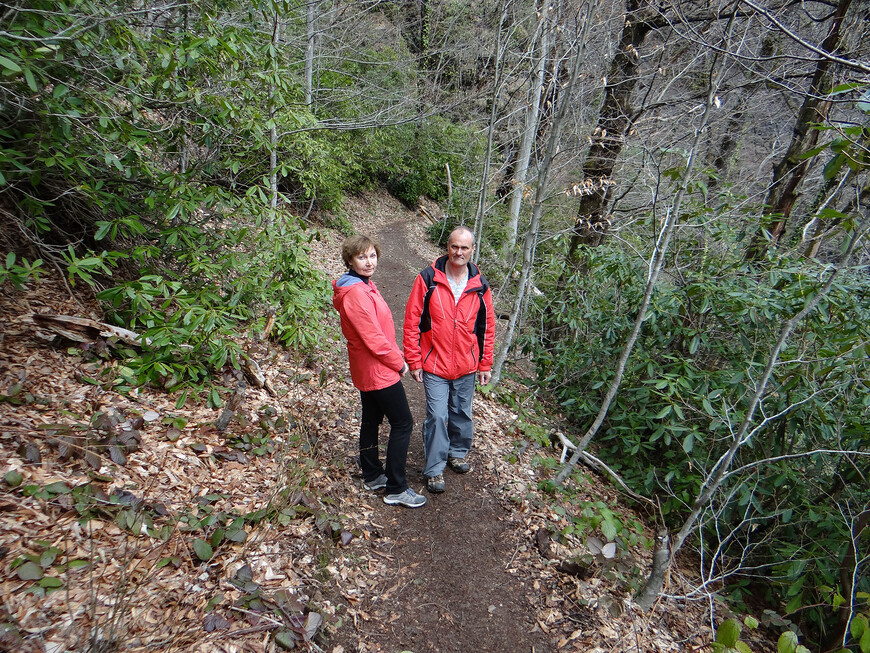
[526,219,870,633]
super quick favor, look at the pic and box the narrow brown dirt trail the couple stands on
[344,221,550,653]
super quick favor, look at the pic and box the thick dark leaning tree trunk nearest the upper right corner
[746,0,852,261]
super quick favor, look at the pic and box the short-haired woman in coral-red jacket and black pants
[332,236,426,508]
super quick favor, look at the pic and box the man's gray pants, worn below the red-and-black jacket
[423,372,475,478]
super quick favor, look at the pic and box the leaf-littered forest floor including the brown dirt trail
[0,188,768,653]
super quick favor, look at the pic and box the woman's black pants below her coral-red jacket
[359,381,414,494]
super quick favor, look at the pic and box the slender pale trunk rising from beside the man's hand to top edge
[490,3,592,387]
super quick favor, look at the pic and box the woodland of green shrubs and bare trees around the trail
[0,0,870,653]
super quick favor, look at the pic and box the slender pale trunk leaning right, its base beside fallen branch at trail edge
[556,38,719,485]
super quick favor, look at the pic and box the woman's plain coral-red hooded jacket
[332,274,405,392]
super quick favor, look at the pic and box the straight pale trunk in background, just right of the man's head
[502,1,550,258]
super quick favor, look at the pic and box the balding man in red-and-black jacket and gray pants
[403,227,495,492]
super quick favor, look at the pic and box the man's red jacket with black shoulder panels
[403,256,495,380]
